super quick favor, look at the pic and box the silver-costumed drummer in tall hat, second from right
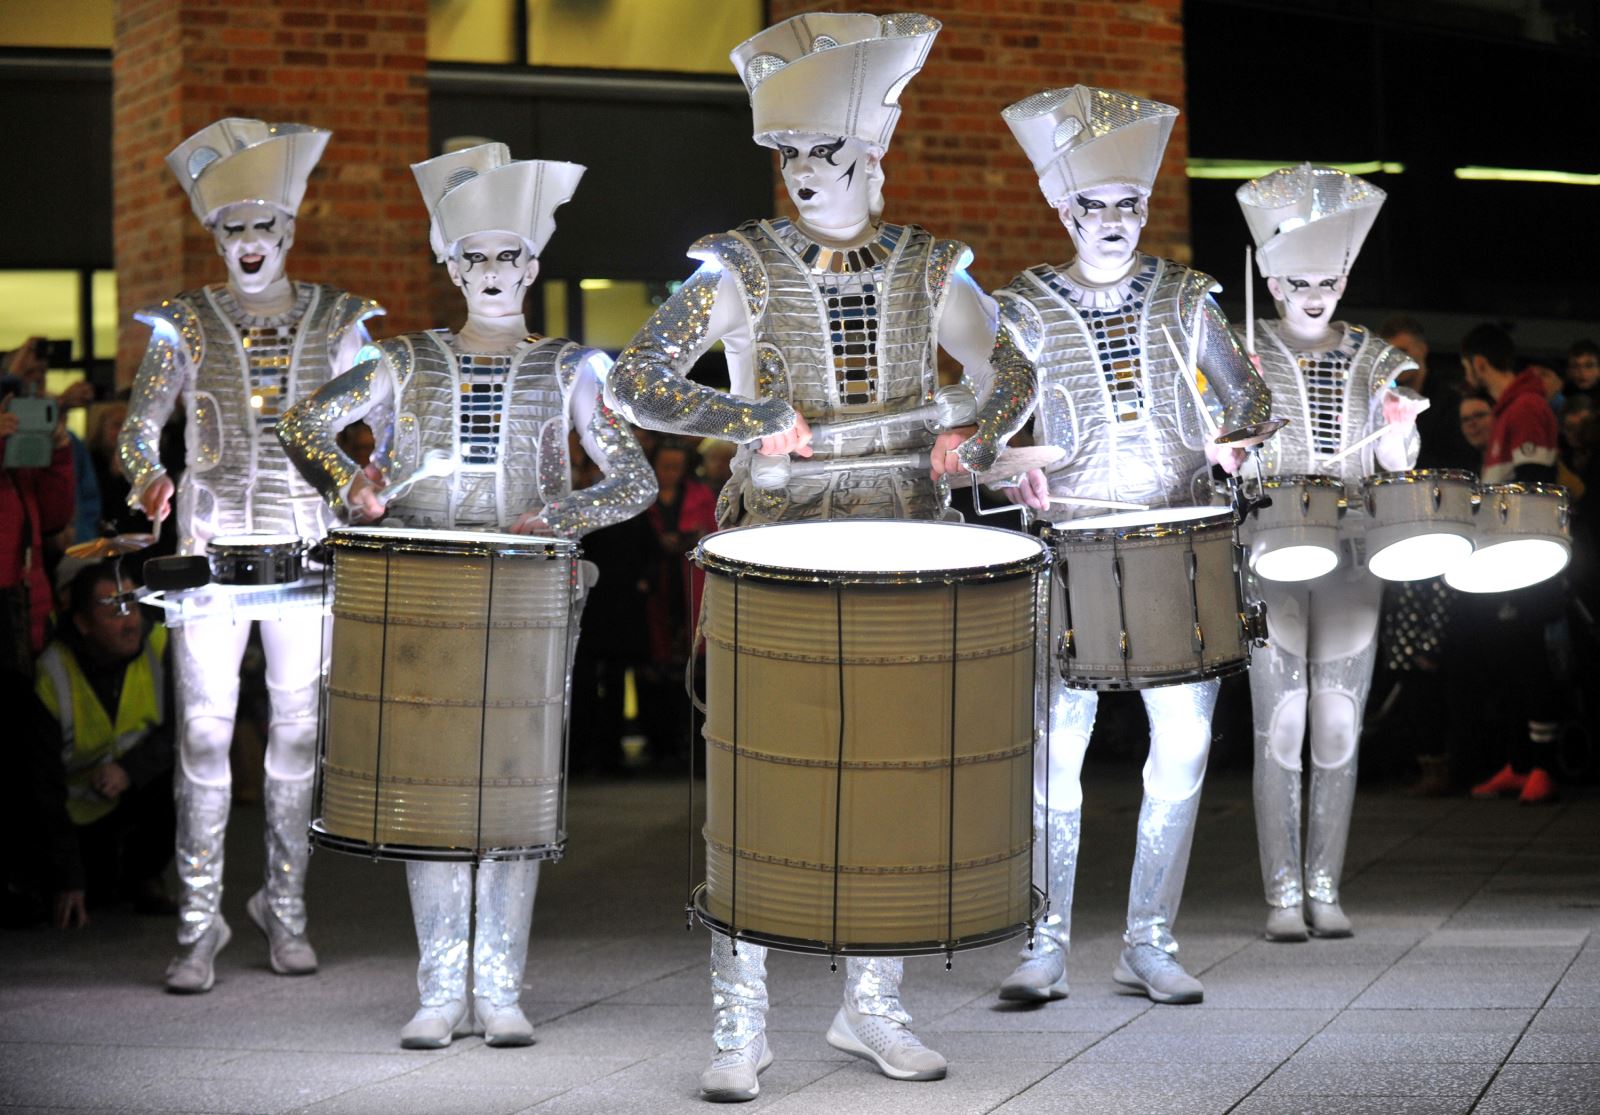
[997,85,1267,1003]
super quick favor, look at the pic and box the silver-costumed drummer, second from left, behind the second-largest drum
[278,144,656,1049]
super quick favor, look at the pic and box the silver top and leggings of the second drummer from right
[997,254,1267,957]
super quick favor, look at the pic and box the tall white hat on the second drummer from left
[411,142,586,259]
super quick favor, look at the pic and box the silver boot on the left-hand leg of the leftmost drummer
[166,773,234,993]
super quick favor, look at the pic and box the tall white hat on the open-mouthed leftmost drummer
[166,117,333,222]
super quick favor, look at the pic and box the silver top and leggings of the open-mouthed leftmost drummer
[117,283,382,945]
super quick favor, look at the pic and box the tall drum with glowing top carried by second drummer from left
[312,526,578,861]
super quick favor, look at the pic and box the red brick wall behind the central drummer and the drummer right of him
[771,0,1189,288]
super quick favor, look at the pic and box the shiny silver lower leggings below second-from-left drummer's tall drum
[405,859,539,1006]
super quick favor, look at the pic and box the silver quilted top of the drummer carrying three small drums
[1235,320,1421,483]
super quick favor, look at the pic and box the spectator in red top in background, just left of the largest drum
[638,437,717,769]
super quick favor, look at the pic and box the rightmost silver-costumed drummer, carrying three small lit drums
[1237,163,1419,941]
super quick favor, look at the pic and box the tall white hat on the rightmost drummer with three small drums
[1234,163,1387,275]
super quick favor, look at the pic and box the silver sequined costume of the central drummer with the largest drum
[606,218,1034,1049]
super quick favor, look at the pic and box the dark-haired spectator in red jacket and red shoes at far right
[1461,323,1565,805]
